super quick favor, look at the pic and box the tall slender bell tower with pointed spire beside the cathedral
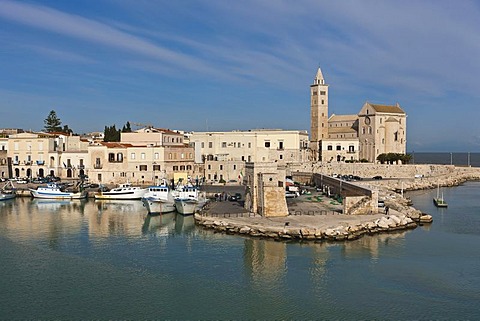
[310,67,328,161]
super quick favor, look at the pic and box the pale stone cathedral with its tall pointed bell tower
[310,68,407,163]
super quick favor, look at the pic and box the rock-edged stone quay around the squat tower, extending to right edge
[195,164,480,241]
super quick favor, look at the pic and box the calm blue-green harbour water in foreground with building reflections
[0,182,480,320]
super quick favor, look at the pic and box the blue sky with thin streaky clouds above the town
[0,0,480,152]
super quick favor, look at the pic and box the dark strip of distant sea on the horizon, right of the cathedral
[408,152,480,167]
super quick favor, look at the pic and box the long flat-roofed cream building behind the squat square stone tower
[189,129,309,183]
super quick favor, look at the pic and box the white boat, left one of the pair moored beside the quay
[142,185,175,215]
